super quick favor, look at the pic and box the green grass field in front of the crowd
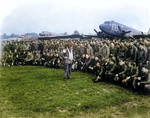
[0,66,150,118]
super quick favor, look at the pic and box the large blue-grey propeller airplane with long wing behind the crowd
[38,21,150,40]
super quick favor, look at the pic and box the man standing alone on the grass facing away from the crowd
[61,44,73,81]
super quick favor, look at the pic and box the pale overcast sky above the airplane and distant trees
[0,0,150,34]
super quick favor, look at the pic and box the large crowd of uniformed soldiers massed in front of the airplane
[1,39,150,90]
